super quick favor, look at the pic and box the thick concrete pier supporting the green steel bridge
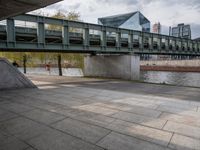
[84,55,140,80]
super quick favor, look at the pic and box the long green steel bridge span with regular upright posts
[0,15,200,56]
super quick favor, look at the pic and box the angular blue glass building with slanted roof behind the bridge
[98,11,150,32]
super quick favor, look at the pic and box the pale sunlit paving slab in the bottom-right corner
[169,134,200,150]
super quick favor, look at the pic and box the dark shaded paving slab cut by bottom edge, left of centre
[28,127,103,150]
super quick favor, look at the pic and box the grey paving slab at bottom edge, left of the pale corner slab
[98,132,170,150]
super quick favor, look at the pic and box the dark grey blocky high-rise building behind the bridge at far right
[171,23,192,39]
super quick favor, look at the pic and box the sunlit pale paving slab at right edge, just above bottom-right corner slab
[164,121,200,139]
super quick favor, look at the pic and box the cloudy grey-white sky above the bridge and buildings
[33,0,200,38]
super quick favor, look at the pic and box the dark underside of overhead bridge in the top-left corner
[0,0,61,20]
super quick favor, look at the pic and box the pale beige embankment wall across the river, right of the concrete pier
[140,60,200,67]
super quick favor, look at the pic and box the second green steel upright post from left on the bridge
[37,16,45,48]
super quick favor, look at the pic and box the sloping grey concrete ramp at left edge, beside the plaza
[0,58,36,90]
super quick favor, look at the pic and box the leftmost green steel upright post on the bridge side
[6,18,16,47]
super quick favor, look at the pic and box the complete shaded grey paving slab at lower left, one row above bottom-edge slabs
[23,109,66,125]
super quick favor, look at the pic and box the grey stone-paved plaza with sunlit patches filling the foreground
[0,76,200,150]
